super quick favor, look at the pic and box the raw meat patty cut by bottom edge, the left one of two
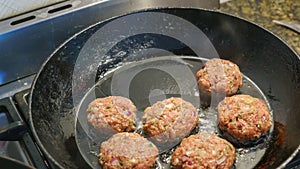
[98,132,158,169]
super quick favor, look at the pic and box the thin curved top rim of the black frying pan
[28,4,300,169]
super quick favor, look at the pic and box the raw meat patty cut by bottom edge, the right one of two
[171,133,235,169]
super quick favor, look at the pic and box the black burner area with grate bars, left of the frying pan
[0,81,47,168]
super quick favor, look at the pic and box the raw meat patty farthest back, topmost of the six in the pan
[196,58,242,96]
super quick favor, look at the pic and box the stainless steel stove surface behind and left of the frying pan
[0,0,300,168]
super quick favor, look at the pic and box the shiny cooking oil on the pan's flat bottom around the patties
[75,56,273,169]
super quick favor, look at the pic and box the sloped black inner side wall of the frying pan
[30,8,300,168]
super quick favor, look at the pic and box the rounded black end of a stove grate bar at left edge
[0,121,28,141]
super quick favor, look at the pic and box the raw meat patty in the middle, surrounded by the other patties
[142,97,199,142]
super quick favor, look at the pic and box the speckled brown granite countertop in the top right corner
[220,0,300,55]
